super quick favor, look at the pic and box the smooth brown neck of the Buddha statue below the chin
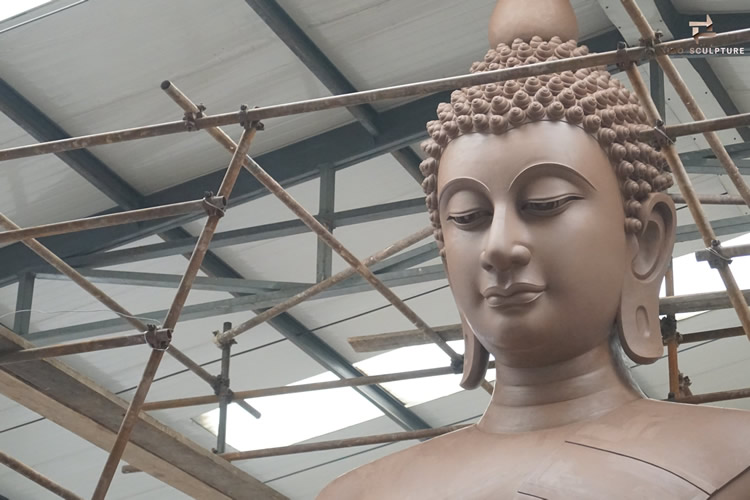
[478,342,641,433]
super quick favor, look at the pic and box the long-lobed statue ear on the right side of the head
[617,193,677,364]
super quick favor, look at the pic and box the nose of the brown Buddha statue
[480,210,531,272]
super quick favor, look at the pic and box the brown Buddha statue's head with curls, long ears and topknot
[421,0,675,388]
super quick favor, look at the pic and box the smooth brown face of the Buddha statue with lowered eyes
[438,121,637,366]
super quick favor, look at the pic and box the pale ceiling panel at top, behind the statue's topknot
[280,0,611,109]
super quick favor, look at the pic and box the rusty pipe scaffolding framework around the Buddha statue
[0,0,750,500]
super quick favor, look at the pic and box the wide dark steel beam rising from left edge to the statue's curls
[0,93,450,286]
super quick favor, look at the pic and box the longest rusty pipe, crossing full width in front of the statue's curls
[0,29,750,161]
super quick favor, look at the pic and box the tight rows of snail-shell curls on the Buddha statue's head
[420,36,672,255]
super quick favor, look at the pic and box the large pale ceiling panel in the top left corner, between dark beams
[0,0,352,194]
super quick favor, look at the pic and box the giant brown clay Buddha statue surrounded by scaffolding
[319,0,750,500]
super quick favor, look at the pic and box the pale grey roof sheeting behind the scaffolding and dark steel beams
[0,0,750,499]
